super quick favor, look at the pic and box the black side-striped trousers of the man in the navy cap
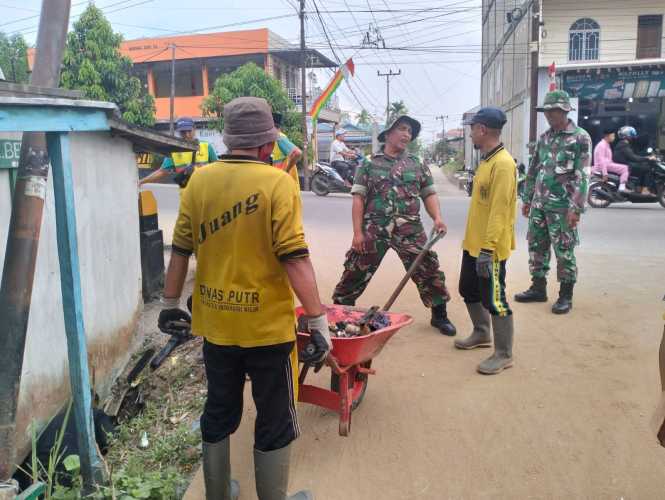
[459,250,512,316]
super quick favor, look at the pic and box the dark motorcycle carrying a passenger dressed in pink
[588,150,665,208]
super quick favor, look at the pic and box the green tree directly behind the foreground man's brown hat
[202,62,303,147]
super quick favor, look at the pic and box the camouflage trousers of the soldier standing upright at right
[527,208,579,283]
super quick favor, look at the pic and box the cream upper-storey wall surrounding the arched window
[540,0,665,66]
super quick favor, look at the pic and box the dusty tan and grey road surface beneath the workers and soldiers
[145,169,665,500]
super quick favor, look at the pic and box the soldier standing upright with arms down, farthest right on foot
[515,90,591,314]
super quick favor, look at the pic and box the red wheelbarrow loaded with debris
[296,306,413,436]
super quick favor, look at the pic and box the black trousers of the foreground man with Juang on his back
[201,340,300,451]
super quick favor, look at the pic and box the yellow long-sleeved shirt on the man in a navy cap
[462,145,517,260]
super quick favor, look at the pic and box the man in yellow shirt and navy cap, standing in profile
[455,108,517,375]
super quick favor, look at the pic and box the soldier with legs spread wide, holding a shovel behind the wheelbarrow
[333,116,456,336]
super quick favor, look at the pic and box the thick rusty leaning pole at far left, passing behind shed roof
[0,0,71,482]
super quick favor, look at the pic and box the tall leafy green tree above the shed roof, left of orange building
[60,4,155,126]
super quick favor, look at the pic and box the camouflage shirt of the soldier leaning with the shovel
[351,152,436,220]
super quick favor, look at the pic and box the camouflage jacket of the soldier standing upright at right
[522,120,591,214]
